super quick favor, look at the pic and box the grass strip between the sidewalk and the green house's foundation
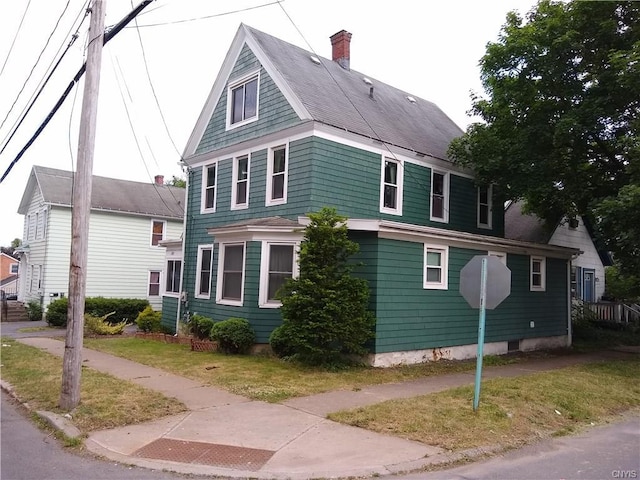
[84,338,475,402]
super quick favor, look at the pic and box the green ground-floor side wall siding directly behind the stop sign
[375,239,567,353]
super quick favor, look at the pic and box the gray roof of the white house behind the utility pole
[18,166,185,218]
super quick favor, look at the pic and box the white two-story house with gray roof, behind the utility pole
[18,166,185,309]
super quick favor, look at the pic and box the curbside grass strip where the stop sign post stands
[329,357,640,450]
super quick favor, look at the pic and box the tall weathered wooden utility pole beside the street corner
[60,0,106,411]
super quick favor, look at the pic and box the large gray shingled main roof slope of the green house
[244,25,463,159]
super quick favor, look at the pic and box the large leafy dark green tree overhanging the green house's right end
[449,0,640,268]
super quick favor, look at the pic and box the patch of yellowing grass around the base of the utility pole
[0,337,186,433]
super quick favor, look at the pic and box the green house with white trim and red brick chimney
[163,25,577,366]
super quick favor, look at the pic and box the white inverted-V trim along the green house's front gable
[182,24,311,158]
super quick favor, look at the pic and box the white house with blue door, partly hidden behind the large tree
[504,202,611,302]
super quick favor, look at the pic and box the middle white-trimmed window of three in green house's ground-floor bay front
[216,243,245,305]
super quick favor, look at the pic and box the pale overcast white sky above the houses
[0,0,536,246]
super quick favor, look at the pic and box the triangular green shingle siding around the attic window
[196,45,300,154]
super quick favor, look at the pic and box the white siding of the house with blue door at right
[549,218,605,301]
